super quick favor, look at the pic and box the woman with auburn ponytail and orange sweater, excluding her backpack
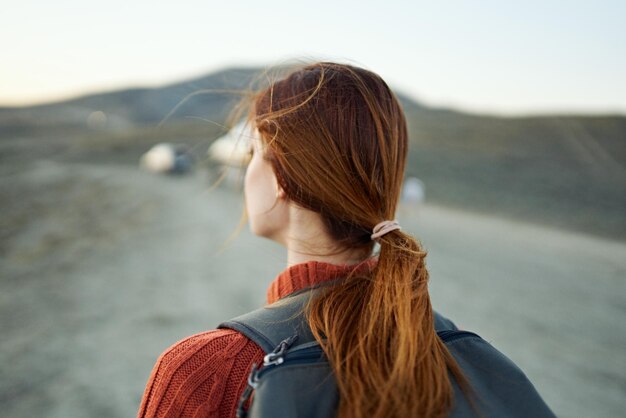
[139,62,549,417]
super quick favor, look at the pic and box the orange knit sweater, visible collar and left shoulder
[137,258,377,418]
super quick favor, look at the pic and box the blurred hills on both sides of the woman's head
[0,68,626,240]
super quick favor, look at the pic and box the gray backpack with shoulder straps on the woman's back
[219,289,555,418]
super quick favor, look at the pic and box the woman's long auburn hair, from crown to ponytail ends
[236,62,473,418]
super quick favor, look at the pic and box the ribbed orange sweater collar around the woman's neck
[267,257,378,304]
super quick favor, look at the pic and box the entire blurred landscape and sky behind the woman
[0,0,626,417]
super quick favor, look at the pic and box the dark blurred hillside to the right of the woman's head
[407,110,626,239]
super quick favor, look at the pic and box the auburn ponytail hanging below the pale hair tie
[307,231,476,418]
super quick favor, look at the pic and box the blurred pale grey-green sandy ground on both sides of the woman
[0,160,626,417]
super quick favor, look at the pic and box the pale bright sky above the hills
[0,0,626,115]
